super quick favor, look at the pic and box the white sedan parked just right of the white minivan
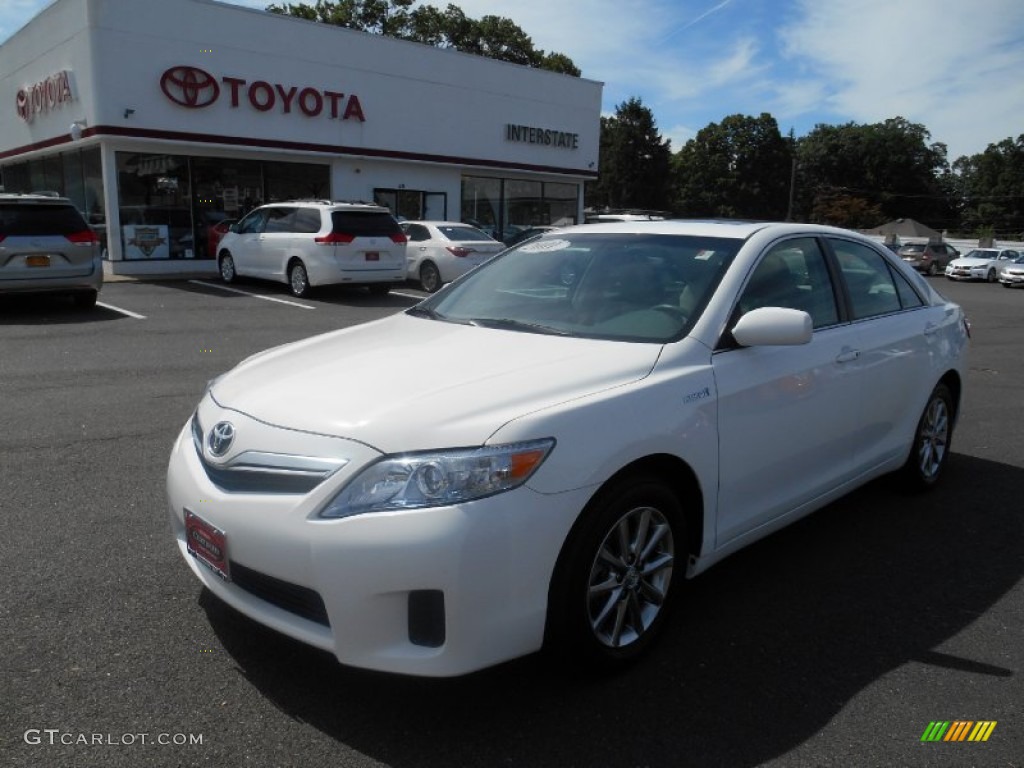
[401,221,505,293]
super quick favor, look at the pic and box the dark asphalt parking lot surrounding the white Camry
[0,279,1024,768]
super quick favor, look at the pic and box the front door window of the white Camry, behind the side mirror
[739,238,839,328]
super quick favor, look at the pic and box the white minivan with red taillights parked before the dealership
[217,200,407,296]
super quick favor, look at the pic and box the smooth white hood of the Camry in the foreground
[210,314,662,454]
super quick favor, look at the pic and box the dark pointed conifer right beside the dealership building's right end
[587,97,672,210]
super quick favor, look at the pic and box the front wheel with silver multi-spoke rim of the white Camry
[546,476,686,670]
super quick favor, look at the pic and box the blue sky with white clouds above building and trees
[0,0,1024,161]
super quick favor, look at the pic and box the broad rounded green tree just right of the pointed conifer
[673,113,793,220]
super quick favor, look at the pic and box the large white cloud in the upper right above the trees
[780,0,1024,159]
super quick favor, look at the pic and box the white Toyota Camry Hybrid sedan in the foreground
[167,221,970,676]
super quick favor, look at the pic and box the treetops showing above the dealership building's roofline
[266,0,580,77]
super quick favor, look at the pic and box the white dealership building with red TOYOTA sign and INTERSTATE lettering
[0,0,602,274]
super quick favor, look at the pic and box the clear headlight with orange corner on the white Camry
[318,437,555,519]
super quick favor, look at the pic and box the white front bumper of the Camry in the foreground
[167,417,589,676]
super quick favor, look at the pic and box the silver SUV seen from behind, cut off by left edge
[0,194,103,307]
